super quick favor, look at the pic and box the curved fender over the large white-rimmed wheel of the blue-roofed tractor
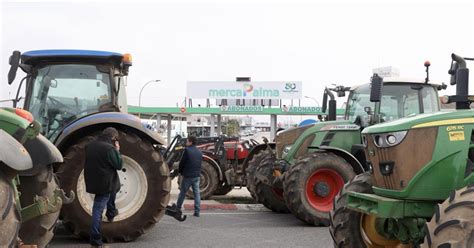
[54,112,166,150]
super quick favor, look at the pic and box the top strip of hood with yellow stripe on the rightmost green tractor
[362,110,474,134]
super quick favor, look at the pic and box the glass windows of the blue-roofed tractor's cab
[25,64,112,138]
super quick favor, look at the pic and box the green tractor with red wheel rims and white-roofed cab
[250,64,446,226]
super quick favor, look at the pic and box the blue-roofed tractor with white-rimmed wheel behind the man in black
[8,50,171,242]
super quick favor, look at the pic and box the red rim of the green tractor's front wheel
[306,169,344,212]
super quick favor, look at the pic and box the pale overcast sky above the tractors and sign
[0,1,474,111]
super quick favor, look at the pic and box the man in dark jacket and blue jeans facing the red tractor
[176,136,202,217]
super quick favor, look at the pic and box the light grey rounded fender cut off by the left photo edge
[0,129,33,171]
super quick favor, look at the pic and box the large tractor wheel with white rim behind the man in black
[57,130,171,242]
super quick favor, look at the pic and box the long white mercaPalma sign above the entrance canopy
[186,81,302,99]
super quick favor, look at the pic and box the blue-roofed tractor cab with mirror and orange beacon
[9,50,132,139]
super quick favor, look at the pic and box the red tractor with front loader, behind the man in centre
[165,136,259,199]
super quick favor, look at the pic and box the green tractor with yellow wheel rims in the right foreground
[330,54,474,248]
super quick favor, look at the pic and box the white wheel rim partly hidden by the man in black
[77,155,148,222]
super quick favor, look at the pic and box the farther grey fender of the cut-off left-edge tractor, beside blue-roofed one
[19,134,63,176]
